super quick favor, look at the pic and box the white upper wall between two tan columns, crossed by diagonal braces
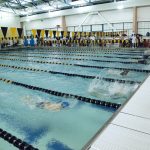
[66,9,133,26]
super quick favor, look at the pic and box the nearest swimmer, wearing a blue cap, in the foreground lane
[24,96,69,111]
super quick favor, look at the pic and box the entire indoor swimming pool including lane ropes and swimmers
[0,48,150,150]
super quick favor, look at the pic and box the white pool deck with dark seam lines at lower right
[88,76,150,150]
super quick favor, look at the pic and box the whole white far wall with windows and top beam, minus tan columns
[20,0,150,35]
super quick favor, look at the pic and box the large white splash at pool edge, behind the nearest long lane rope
[88,78,138,99]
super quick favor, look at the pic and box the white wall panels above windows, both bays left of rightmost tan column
[24,8,133,30]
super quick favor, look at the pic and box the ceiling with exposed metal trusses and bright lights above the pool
[0,0,124,16]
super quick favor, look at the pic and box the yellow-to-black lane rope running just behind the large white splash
[0,64,141,84]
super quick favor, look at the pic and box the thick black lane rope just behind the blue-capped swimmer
[0,78,121,110]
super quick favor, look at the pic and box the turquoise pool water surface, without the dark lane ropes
[0,49,149,150]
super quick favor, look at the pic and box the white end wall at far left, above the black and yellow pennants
[0,11,21,28]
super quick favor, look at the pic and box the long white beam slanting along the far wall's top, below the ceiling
[21,0,150,22]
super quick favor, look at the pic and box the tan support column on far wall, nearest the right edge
[132,7,138,34]
